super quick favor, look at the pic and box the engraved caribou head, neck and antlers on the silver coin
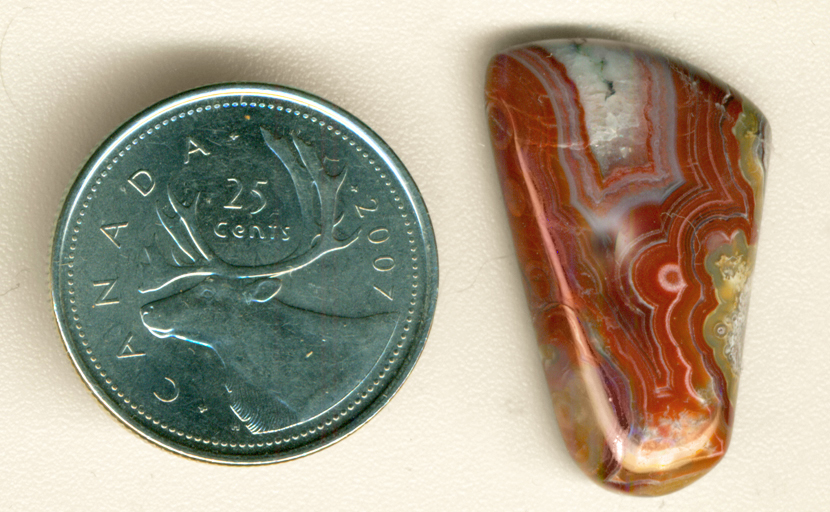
[140,129,384,434]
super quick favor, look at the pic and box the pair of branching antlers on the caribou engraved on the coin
[139,129,360,293]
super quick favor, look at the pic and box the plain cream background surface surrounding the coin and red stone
[0,0,830,511]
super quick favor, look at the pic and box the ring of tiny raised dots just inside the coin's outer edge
[66,101,426,448]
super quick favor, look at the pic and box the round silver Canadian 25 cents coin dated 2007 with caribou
[52,84,438,464]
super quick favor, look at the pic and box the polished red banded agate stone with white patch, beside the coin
[486,40,769,494]
